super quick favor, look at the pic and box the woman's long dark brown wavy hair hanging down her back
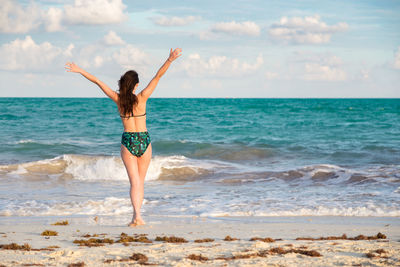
[118,70,139,116]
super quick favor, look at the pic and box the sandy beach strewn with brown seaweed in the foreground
[0,216,400,266]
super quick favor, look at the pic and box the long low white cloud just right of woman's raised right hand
[180,54,264,77]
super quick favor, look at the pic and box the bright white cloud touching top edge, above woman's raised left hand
[64,0,127,24]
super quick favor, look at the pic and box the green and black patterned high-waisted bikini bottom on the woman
[121,131,150,158]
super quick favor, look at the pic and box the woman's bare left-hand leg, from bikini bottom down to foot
[121,145,144,226]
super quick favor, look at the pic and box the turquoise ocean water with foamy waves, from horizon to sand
[0,98,400,224]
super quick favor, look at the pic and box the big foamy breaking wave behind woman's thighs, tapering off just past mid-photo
[0,154,230,181]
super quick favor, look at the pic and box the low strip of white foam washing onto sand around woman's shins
[0,197,400,217]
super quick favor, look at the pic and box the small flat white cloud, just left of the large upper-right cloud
[211,21,260,36]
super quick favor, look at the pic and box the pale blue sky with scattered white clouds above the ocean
[0,0,400,97]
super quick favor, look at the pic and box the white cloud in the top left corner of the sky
[0,0,41,33]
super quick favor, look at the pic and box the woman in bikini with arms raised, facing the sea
[65,48,182,226]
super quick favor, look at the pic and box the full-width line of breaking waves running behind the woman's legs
[0,154,400,185]
